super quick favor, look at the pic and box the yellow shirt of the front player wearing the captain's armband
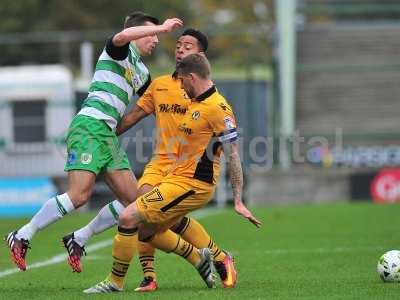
[172,86,238,184]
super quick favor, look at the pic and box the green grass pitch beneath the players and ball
[0,204,400,299]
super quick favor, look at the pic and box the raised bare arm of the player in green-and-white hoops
[112,18,183,47]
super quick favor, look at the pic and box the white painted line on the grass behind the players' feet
[0,208,220,278]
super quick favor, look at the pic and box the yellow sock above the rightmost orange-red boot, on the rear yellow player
[175,217,226,261]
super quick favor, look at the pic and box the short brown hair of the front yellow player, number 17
[176,53,211,79]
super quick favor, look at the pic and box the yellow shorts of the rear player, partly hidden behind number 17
[138,155,175,188]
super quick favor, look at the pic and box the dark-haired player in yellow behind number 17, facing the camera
[117,28,236,292]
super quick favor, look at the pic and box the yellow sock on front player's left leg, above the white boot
[108,227,138,288]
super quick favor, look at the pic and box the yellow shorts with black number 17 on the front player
[136,175,215,228]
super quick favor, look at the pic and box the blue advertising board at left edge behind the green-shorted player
[0,177,57,217]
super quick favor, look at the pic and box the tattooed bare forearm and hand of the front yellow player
[223,142,262,227]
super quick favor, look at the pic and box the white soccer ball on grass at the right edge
[376,250,400,282]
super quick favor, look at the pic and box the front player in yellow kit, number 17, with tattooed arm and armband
[85,54,261,293]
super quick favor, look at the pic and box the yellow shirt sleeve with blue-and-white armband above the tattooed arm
[210,104,238,143]
